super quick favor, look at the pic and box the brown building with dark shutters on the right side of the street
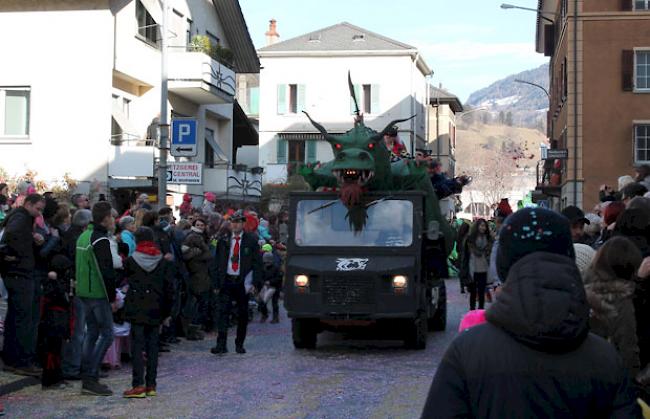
[536,0,650,210]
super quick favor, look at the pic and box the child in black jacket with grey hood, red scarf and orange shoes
[124,227,174,398]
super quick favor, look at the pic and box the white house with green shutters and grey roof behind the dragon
[258,22,431,182]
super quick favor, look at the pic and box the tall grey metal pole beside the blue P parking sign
[158,0,169,208]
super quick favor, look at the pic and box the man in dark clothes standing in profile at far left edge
[0,194,45,377]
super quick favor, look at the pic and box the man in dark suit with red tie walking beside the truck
[210,210,262,354]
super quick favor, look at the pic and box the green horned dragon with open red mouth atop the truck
[299,75,453,254]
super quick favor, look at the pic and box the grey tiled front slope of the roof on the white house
[259,22,417,53]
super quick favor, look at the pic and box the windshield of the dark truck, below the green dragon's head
[294,199,413,247]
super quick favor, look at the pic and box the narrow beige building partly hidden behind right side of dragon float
[427,86,463,177]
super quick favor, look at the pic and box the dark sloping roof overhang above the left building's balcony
[212,0,260,73]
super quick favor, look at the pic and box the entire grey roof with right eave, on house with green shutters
[257,22,432,75]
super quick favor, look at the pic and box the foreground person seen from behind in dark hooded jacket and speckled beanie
[422,209,640,419]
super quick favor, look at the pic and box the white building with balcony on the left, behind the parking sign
[0,0,259,210]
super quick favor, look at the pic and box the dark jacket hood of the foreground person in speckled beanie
[486,252,589,353]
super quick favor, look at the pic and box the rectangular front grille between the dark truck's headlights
[323,276,375,309]
